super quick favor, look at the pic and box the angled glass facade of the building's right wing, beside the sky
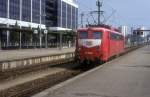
[57,0,78,29]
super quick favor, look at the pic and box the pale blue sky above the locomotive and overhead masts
[78,0,150,28]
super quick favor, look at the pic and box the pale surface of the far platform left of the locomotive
[0,48,75,61]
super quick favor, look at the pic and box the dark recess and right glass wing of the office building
[46,0,78,30]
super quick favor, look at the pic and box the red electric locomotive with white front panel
[75,25,124,63]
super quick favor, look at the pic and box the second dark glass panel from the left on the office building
[9,0,20,20]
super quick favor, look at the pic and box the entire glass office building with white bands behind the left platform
[0,0,78,46]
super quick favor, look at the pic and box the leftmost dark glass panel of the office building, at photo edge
[0,0,7,18]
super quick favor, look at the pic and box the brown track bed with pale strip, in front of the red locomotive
[0,63,82,97]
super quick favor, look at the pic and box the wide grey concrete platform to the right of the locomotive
[33,46,150,97]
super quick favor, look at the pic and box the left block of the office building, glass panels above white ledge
[0,0,45,28]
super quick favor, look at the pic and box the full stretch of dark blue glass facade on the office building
[0,0,78,29]
